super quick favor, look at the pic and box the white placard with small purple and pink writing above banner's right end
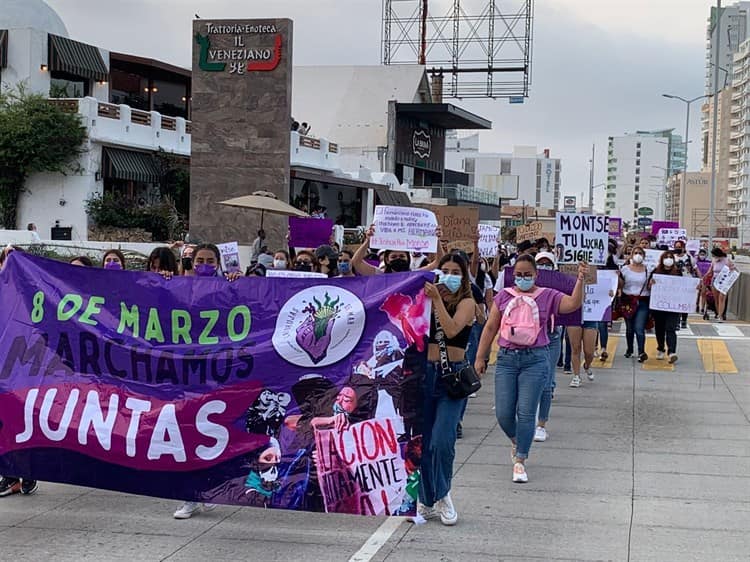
[370,205,438,250]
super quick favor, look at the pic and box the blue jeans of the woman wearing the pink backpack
[495,345,549,459]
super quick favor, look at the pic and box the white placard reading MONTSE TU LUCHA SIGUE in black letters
[555,213,609,265]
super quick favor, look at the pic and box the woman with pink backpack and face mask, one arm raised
[474,255,588,482]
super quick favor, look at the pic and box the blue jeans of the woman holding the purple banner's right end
[419,361,466,507]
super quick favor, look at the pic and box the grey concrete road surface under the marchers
[0,320,750,562]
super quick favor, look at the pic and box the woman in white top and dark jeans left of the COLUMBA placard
[617,247,651,363]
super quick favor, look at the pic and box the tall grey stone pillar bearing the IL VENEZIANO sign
[190,19,292,246]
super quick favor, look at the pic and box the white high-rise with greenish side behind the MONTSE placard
[605,129,685,222]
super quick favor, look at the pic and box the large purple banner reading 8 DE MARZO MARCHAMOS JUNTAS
[0,252,432,515]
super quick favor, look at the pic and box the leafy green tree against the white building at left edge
[0,86,86,228]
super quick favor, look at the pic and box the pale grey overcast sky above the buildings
[47,0,713,208]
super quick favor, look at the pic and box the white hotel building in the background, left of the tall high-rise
[445,134,562,209]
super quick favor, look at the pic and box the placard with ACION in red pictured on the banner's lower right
[315,419,416,515]
